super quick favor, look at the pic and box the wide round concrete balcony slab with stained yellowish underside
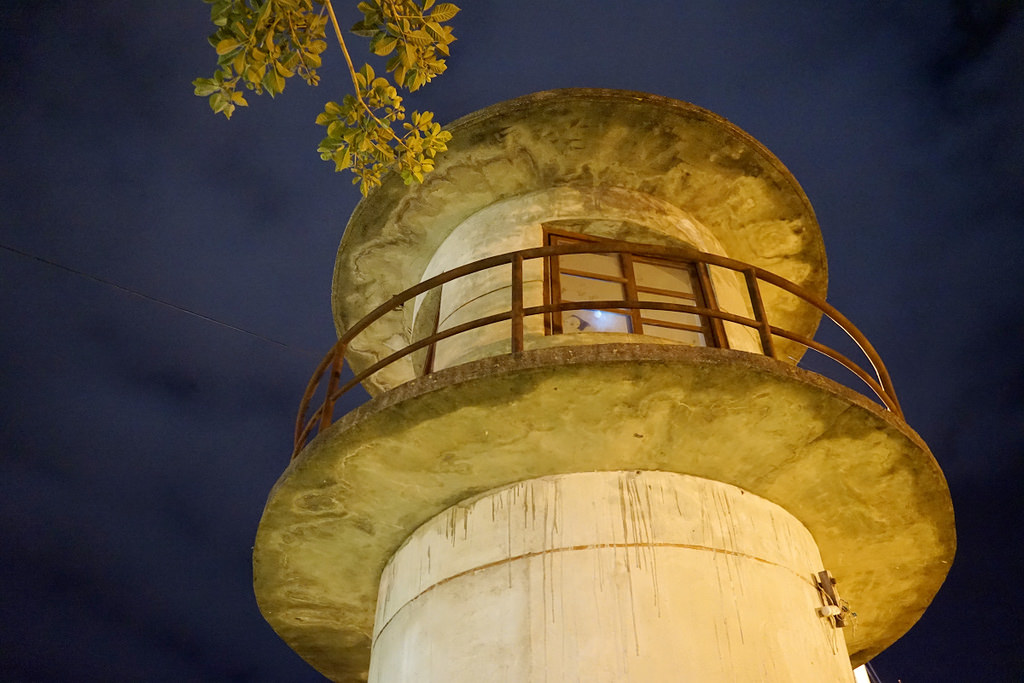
[254,344,955,681]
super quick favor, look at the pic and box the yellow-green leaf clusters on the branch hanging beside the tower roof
[193,0,459,195]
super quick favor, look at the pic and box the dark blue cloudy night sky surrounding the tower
[0,0,1024,683]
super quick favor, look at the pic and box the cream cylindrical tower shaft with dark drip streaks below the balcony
[370,471,853,683]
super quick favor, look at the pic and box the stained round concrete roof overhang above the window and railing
[332,89,827,394]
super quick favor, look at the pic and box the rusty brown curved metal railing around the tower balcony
[292,241,903,458]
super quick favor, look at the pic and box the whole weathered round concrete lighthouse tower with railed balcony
[254,90,955,683]
